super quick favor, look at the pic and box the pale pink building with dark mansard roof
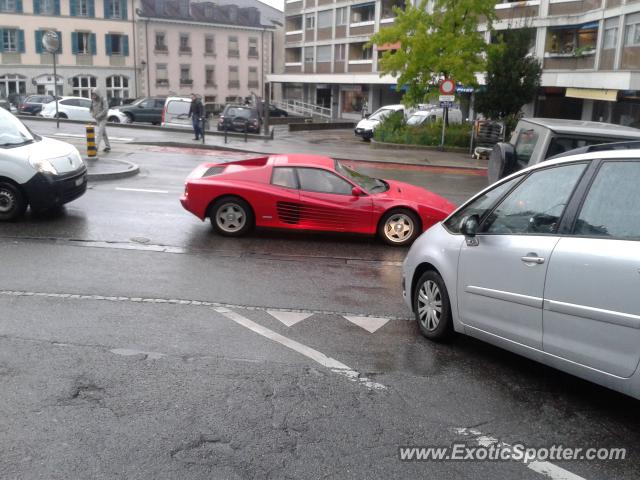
[138,0,284,103]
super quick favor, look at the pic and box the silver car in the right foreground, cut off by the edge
[403,149,640,398]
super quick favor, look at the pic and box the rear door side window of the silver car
[574,161,640,240]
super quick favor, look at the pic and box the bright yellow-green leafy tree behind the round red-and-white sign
[370,0,496,105]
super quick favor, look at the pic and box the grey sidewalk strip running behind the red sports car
[134,126,487,169]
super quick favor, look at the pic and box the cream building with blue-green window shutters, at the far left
[0,0,137,98]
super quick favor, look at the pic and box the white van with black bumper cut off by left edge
[0,108,87,221]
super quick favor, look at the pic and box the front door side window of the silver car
[480,164,586,235]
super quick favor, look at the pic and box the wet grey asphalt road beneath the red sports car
[0,125,640,479]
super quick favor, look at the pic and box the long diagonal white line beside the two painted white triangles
[214,308,387,390]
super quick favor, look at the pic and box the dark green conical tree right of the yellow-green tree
[476,28,542,123]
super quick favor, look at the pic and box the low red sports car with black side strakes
[180,155,455,245]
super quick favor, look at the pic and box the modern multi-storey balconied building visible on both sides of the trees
[269,0,640,125]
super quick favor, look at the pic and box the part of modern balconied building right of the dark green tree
[487,0,640,126]
